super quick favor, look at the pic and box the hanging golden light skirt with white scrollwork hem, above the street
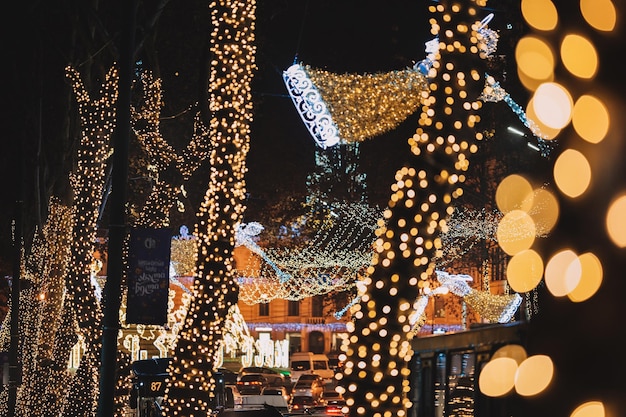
[283,63,428,148]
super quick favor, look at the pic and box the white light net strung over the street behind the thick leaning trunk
[236,203,522,305]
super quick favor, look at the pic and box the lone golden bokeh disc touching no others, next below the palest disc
[553,149,591,198]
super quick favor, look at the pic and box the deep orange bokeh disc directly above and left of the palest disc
[515,36,555,80]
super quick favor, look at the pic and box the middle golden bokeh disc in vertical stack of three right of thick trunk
[496,210,536,255]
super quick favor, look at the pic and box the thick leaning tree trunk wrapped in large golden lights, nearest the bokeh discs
[340,0,486,417]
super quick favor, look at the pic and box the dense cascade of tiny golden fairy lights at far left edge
[0,198,75,415]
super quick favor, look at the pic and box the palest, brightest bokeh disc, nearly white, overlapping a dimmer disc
[533,82,574,129]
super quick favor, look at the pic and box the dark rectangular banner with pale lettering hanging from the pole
[126,228,172,324]
